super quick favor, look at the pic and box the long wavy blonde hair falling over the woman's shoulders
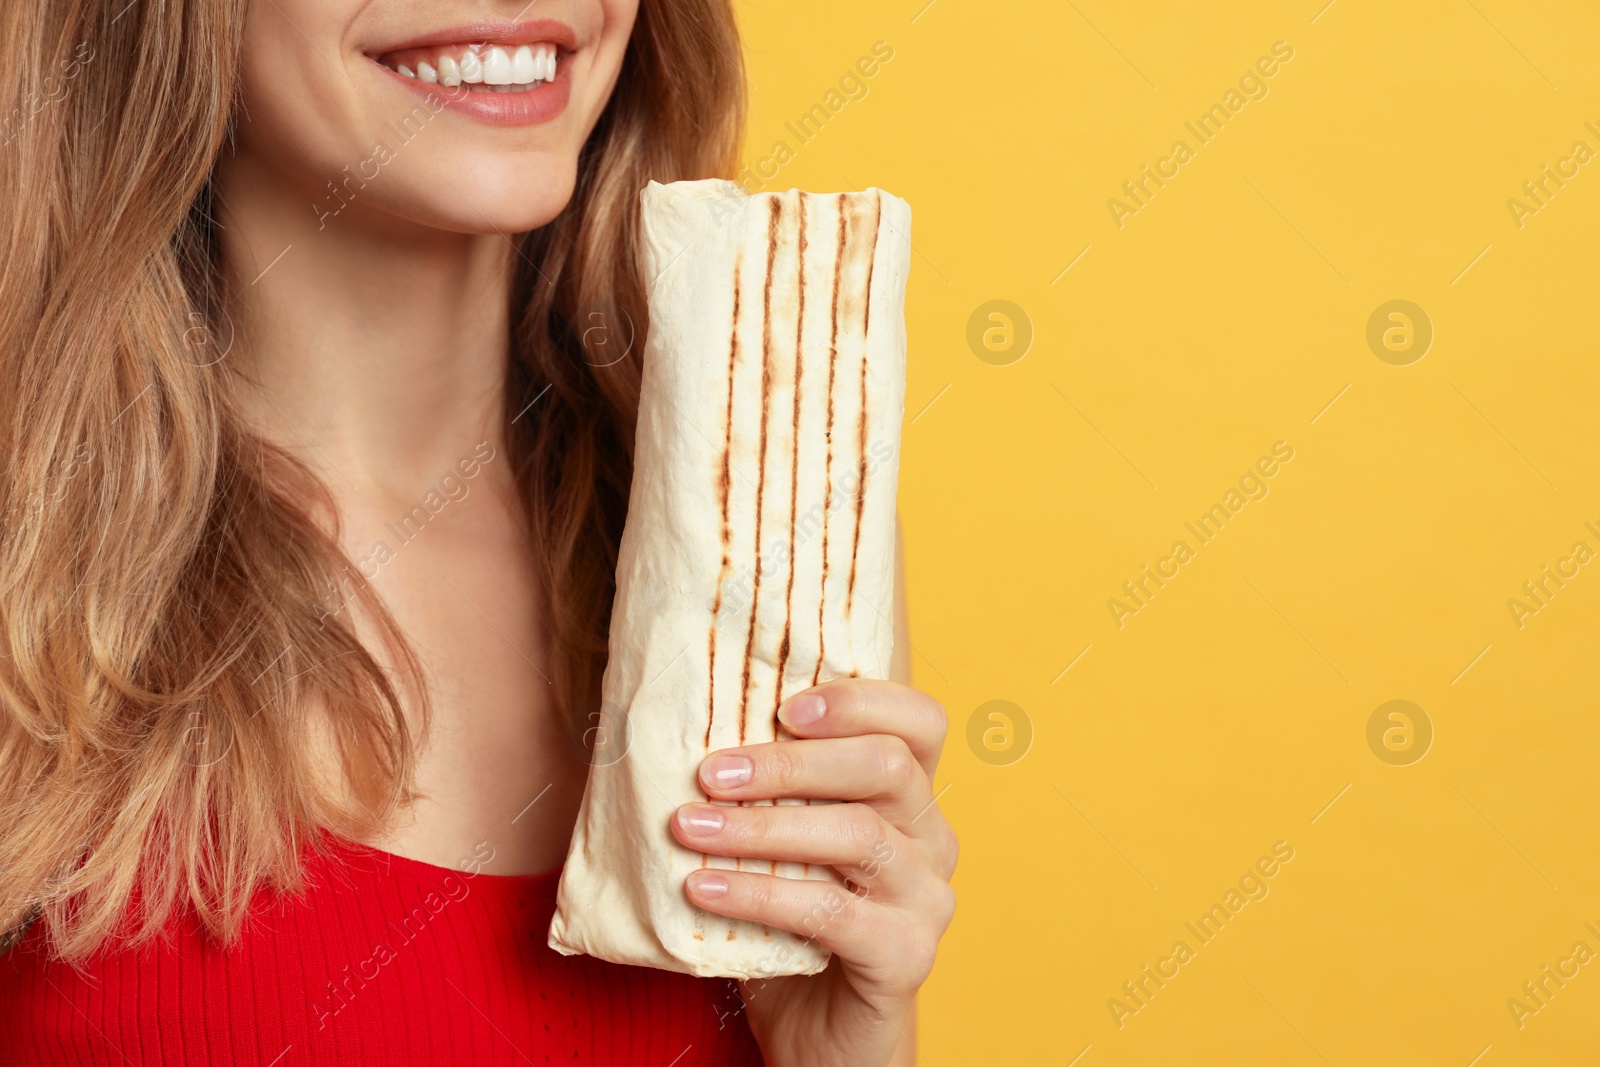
[0,0,744,961]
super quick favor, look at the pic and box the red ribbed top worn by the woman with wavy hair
[0,841,762,1067]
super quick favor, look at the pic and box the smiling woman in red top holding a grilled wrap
[0,0,955,1067]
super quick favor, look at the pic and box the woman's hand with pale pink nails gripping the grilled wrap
[672,678,957,1067]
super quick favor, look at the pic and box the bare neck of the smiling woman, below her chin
[216,144,515,499]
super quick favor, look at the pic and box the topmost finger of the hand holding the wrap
[778,678,947,782]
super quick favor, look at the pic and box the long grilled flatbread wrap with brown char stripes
[550,181,910,977]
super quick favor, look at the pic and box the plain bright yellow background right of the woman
[739,0,1600,1067]
